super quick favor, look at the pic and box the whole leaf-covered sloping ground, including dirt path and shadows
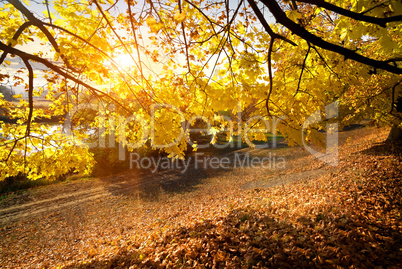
[0,127,402,268]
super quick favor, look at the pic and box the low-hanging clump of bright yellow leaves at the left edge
[0,93,93,180]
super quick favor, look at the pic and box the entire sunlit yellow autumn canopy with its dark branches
[0,0,402,179]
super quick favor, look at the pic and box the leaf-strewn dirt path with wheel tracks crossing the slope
[0,126,370,224]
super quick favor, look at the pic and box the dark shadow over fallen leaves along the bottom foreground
[65,202,402,268]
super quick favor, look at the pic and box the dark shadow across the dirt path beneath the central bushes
[100,142,288,201]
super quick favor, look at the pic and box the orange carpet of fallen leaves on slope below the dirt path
[1,127,402,268]
